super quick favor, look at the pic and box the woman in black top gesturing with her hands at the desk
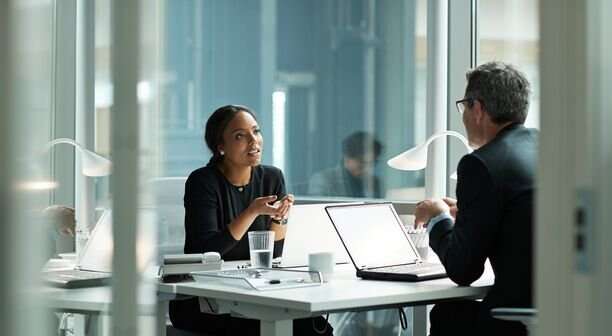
[170,105,332,335]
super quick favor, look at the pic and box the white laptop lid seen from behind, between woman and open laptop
[279,204,349,267]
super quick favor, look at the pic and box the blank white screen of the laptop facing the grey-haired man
[326,203,419,269]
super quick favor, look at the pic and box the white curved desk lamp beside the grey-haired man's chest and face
[387,131,472,180]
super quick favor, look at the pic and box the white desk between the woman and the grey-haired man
[159,265,493,336]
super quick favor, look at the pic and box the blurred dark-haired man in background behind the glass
[308,131,384,198]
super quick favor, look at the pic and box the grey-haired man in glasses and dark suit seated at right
[415,62,538,336]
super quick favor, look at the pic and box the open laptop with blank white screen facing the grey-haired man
[325,203,446,281]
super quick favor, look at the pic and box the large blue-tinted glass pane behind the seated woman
[160,0,427,199]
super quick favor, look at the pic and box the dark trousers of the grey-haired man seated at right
[429,301,527,336]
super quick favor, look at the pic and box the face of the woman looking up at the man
[218,112,263,166]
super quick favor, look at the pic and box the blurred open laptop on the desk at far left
[42,210,113,288]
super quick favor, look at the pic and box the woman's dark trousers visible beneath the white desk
[170,299,334,336]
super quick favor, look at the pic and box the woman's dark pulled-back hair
[204,105,257,166]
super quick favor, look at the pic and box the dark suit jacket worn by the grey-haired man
[429,124,538,310]
